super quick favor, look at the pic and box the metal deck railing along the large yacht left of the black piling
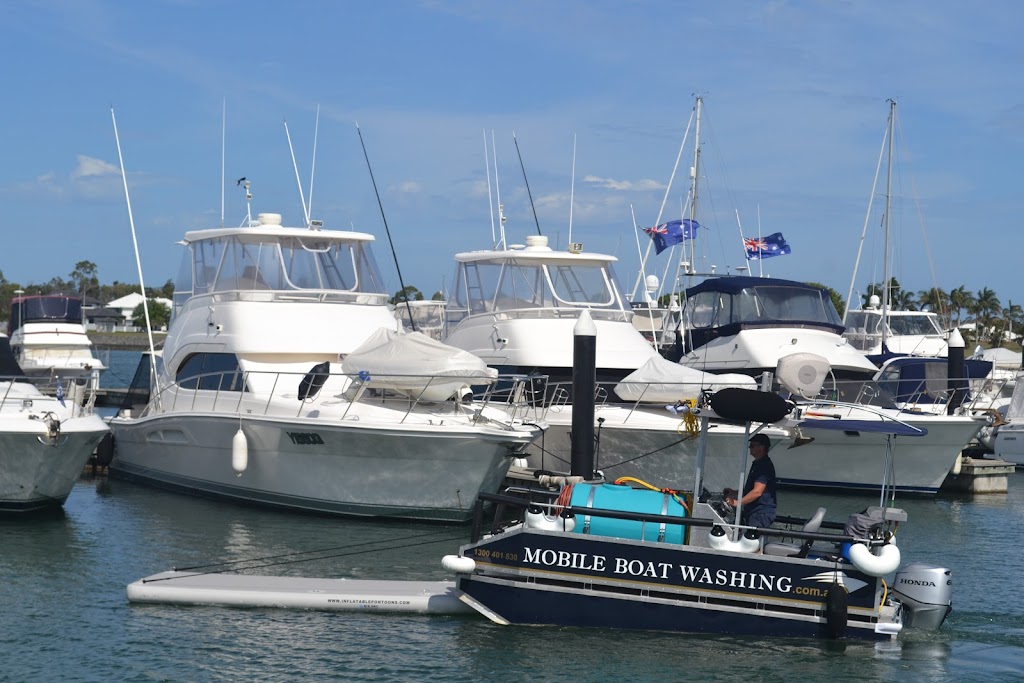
[140,370,536,425]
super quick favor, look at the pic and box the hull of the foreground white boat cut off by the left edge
[0,416,109,512]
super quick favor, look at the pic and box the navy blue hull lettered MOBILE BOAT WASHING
[458,527,900,640]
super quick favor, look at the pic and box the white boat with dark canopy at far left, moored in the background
[7,294,106,387]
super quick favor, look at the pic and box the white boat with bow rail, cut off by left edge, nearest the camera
[0,334,110,512]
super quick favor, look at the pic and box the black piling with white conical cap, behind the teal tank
[569,309,597,479]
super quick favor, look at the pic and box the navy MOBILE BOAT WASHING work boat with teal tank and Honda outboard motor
[442,389,952,639]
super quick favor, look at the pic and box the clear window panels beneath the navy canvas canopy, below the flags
[687,285,843,328]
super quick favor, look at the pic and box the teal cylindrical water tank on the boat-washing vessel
[569,483,686,544]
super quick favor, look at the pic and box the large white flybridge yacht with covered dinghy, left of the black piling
[110,213,541,521]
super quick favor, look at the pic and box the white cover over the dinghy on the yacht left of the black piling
[341,328,498,401]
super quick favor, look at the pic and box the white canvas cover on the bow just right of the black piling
[615,355,758,403]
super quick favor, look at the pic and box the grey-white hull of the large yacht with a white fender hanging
[111,413,537,521]
